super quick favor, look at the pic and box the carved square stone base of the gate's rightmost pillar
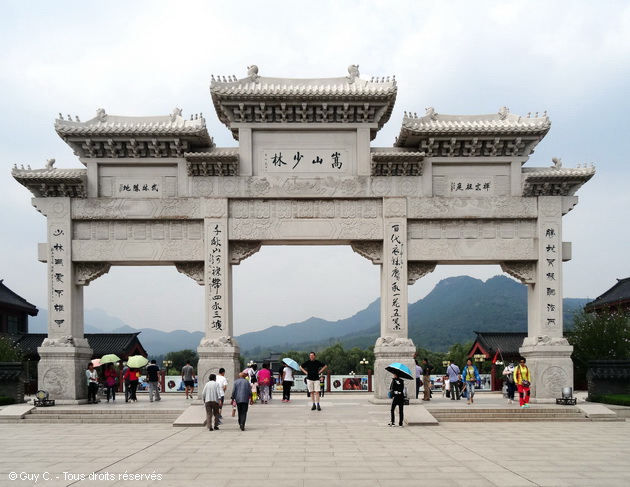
[519,339,573,403]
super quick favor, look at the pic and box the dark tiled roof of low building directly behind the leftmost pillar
[14,332,146,358]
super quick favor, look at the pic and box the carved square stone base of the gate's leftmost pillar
[37,345,92,404]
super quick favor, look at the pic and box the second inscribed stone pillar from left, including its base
[197,198,240,397]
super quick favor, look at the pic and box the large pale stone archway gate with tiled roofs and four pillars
[12,66,594,401]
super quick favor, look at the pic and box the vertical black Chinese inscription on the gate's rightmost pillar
[541,224,561,330]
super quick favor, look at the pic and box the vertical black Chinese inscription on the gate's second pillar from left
[207,223,226,331]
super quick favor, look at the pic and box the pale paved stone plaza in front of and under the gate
[0,394,630,487]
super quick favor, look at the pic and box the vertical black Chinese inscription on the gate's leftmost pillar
[48,223,72,331]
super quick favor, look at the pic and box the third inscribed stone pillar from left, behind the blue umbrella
[374,198,416,400]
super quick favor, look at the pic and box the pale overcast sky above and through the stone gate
[0,0,630,335]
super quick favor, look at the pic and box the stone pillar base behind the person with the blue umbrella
[373,339,416,400]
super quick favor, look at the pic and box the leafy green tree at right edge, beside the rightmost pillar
[567,310,630,383]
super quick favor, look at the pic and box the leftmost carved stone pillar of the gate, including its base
[35,198,92,404]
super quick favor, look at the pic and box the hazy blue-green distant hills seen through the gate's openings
[29,276,589,357]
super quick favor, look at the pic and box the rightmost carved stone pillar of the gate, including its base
[520,196,573,402]
